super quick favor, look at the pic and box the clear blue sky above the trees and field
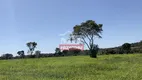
[0,0,142,55]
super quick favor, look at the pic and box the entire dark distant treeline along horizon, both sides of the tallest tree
[0,41,142,60]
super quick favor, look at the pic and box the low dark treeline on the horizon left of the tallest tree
[0,48,89,60]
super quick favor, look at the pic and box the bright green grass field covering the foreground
[0,54,142,80]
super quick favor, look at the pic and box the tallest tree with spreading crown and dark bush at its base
[72,20,103,58]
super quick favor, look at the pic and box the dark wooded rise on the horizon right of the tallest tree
[99,41,142,54]
